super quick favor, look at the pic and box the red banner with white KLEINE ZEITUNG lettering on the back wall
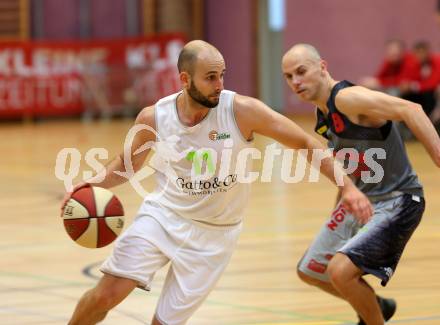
[0,35,184,118]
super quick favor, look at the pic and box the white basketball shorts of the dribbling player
[101,202,242,325]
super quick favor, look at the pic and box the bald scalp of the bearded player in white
[177,40,222,75]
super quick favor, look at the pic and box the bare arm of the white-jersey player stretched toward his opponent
[234,95,373,222]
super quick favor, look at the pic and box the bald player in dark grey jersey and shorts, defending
[282,44,440,325]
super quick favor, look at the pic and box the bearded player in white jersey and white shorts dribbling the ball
[65,41,372,325]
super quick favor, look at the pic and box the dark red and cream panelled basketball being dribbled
[63,186,124,248]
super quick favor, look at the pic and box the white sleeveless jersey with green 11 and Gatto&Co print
[145,90,251,226]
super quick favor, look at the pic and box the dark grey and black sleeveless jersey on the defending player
[315,80,423,197]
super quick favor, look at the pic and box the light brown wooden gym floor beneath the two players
[0,117,440,325]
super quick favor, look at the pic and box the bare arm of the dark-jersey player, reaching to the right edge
[336,86,440,167]
